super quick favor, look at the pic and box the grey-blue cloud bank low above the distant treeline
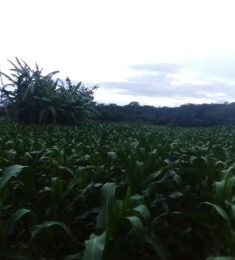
[101,63,235,102]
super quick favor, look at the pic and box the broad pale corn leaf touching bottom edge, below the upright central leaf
[82,232,106,260]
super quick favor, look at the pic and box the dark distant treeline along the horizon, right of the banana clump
[97,101,235,127]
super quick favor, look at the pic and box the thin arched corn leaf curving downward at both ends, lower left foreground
[31,221,71,239]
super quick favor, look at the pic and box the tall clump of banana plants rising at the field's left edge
[0,58,97,124]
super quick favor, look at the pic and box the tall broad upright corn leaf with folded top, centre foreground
[97,183,116,230]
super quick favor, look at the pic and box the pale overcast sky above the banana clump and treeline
[0,0,235,106]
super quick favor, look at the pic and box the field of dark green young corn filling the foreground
[0,122,235,260]
